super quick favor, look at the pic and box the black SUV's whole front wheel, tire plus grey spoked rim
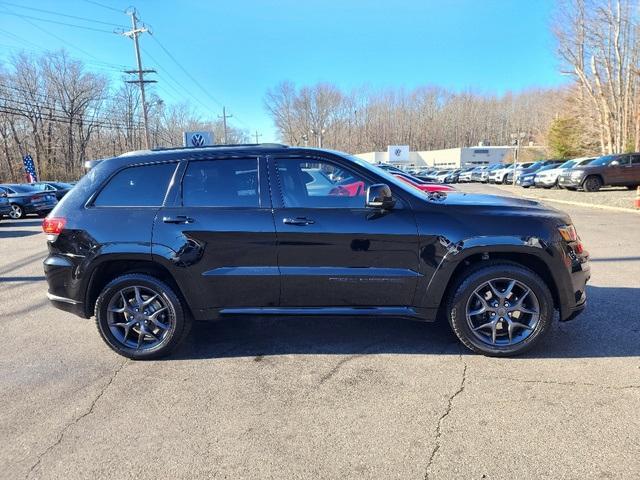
[446,262,554,357]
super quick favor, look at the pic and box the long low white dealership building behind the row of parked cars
[356,145,514,169]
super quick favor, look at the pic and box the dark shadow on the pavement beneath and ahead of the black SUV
[167,287,640,360]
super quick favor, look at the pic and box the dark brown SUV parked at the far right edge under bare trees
[558,153,640,192]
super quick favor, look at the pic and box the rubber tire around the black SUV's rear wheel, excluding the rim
[95,274,185,360]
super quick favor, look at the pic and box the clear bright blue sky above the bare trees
[0,0,565,141]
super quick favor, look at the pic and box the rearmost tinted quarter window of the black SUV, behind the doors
[94,163,176,207]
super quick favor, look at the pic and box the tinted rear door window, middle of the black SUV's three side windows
[182,159,260,207]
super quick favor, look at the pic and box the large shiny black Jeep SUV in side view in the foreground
[43,144,590,359]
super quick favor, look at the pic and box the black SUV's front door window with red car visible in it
[277,159,369,208]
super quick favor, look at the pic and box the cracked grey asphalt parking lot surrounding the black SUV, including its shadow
[0,185,640,479]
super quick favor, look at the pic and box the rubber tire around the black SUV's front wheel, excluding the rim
[448,264,554,356]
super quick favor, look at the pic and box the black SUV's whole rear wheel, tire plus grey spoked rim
[95,273,192,360]
